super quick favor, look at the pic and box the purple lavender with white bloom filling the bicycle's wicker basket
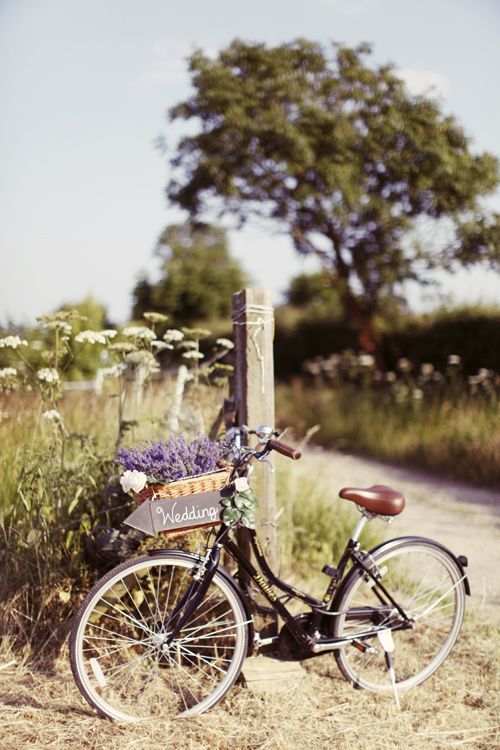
[116,435,227,492]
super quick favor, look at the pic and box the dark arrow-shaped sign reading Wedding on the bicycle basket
[123,492,224,536]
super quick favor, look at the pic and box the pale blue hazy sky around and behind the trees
[0,0,500,324]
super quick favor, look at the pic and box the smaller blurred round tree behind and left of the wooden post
[132,223,246,325]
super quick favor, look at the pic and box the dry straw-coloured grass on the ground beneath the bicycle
[0,616,500,750]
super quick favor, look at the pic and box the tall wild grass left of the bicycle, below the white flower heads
[0,381,222,654]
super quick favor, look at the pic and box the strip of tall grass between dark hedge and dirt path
[277,381,500,486]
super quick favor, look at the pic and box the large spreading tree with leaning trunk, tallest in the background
[167,39,500,351]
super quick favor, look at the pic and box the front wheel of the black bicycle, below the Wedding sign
[70,551,248,721]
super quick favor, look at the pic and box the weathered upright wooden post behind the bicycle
[233,289,278,570]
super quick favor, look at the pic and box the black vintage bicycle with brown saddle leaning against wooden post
[70,427,470,721]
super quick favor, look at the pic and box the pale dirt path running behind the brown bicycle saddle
[307,450,500,621]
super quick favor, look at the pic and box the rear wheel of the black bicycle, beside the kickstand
[333,539,465,692]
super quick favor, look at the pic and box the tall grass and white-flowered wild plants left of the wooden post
[0,310,232,653]
